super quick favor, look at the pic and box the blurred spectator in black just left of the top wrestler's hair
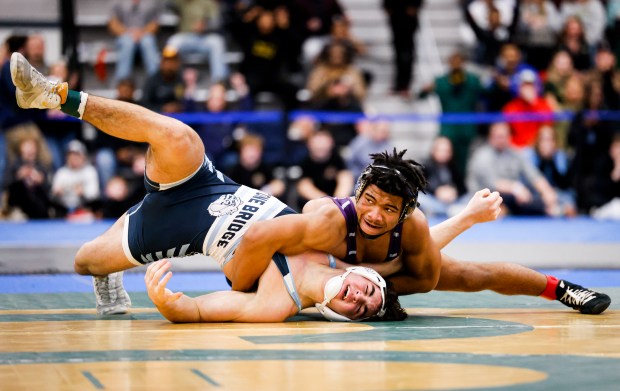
[297,130,353,210]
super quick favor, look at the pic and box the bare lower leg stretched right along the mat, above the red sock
[435,253,547,296]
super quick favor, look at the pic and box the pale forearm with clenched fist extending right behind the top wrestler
[430,189,503,249]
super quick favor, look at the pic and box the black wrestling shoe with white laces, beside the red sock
[555,280,611,315]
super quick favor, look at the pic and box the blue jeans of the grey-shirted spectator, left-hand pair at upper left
[114,34,160,82]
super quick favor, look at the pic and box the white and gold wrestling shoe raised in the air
[11,52,69,109]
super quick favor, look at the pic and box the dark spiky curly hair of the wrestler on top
[355,148,428,219]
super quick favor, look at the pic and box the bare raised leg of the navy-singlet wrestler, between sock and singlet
[82,96,204,183]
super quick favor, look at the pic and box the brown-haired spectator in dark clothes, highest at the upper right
[557,16,592,71]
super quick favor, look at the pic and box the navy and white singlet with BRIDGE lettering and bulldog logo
[123,156,296,267]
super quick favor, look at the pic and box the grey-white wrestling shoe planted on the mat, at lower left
[93,272,131,315]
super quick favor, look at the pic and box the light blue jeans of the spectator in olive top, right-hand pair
[168,33,228,81]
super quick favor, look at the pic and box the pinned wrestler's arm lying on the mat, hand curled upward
[144,260,288,323]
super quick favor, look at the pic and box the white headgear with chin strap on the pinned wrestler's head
[315,266,387,322]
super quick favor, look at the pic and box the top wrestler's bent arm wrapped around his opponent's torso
[229,206,344,291]
